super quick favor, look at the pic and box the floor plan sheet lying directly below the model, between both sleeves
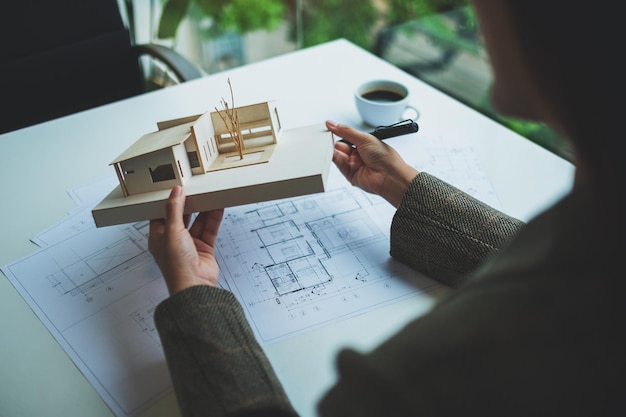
[212,187,432,343]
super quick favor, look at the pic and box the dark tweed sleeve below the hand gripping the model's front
[154,286,297,417]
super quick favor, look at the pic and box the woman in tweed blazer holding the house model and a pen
[150,0,626,416]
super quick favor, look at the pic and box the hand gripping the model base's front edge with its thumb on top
[148,186,224,295]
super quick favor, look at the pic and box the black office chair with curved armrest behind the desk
[0,0,202,133]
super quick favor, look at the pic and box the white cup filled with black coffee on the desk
[354,80,419,127]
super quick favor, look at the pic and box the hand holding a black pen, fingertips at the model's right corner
[326,121,419,208]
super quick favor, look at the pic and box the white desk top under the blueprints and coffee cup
[0,40,573,417]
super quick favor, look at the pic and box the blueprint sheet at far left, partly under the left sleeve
[3,216,171,416]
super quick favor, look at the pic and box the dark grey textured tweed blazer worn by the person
[155,173,626,417]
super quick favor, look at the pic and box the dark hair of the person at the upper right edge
[501,0,626,230]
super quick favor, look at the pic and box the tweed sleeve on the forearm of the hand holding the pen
[390,172,524,287]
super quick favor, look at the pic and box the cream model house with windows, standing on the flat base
[111,101,281,196]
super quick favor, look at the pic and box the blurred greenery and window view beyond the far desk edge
[118,0,573,161]
